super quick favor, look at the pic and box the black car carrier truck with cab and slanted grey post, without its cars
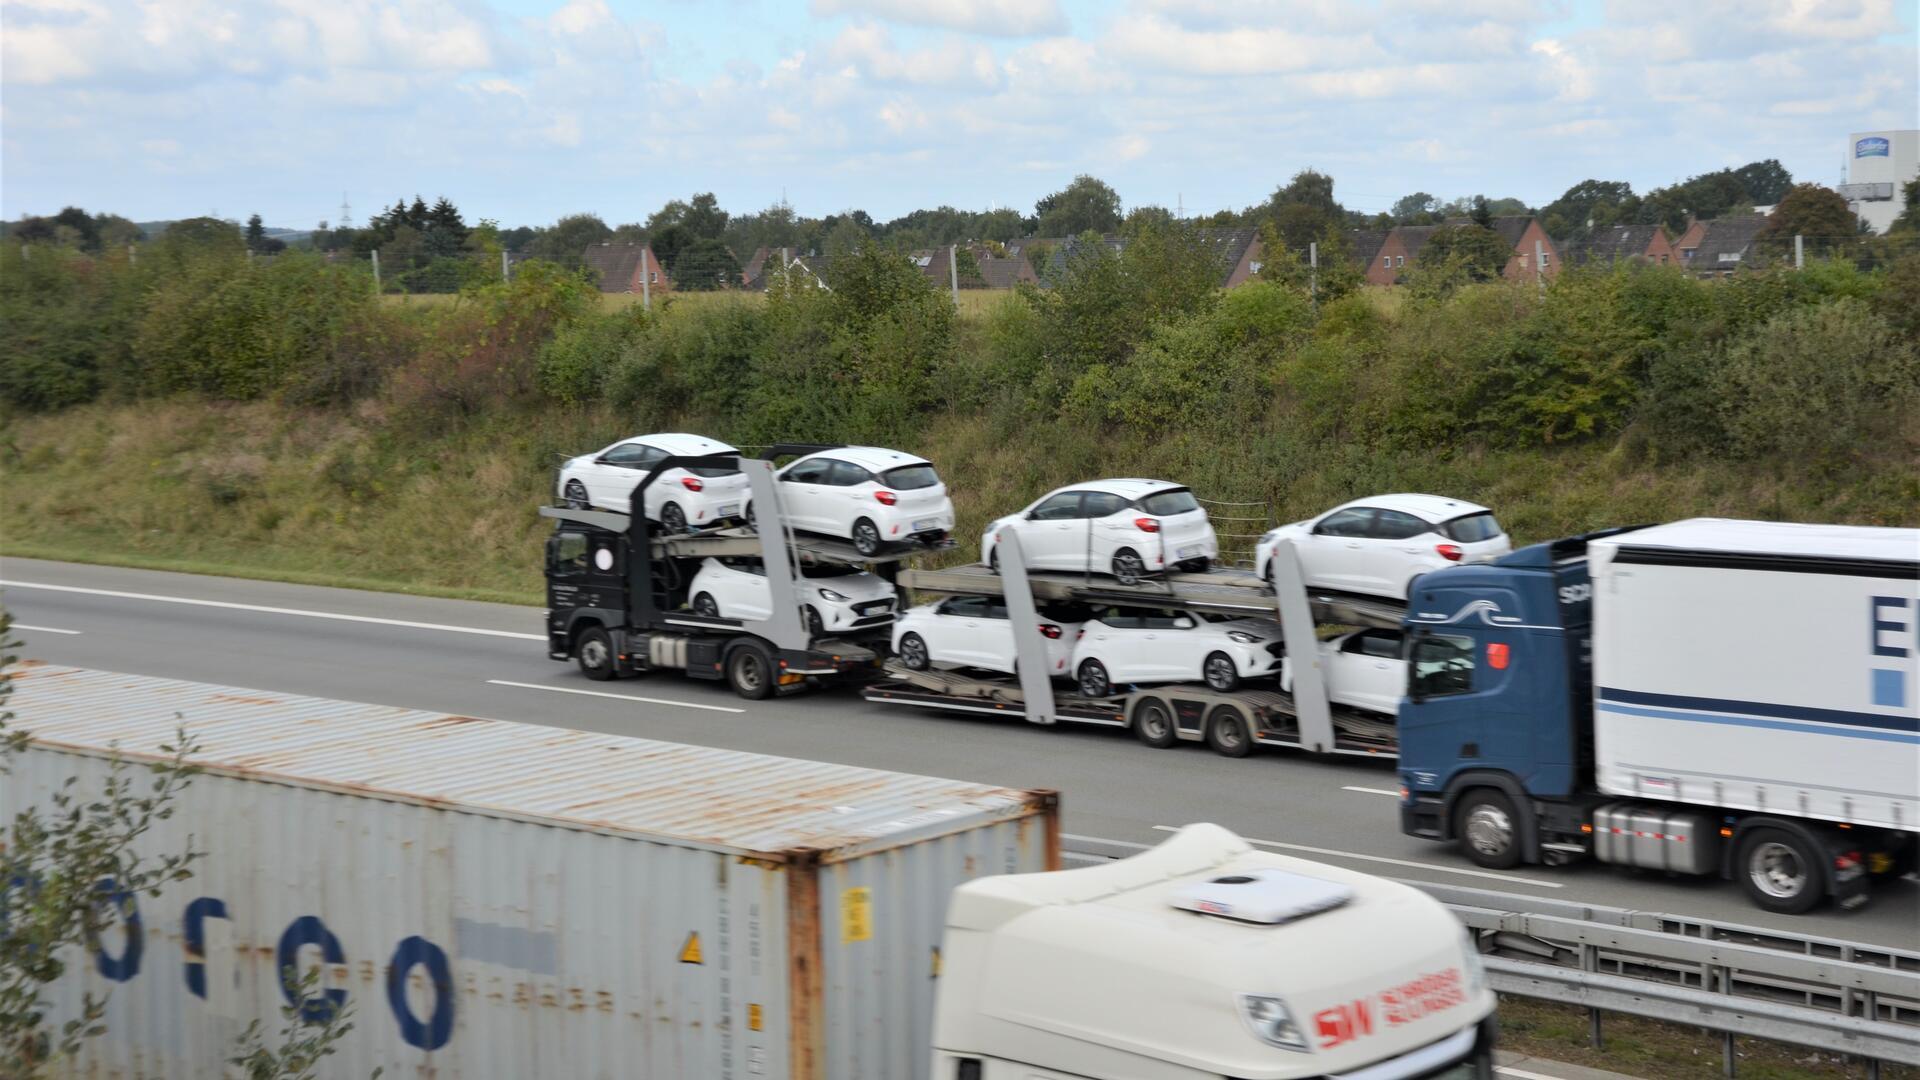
[540,444,936,700]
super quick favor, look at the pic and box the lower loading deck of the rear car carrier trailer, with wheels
[862,663,1398,757]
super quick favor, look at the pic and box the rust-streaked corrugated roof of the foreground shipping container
[10,661,1052,859]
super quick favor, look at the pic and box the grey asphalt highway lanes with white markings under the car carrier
[0,559,1920,947]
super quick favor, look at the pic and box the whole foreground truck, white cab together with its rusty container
[0,665,1494,1080]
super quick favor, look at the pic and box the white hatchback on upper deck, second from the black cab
[780,446,954,555]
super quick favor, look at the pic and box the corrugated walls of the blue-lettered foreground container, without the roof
[0,664,1058,1080]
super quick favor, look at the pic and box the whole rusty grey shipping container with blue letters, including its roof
[0,663,1060,1080]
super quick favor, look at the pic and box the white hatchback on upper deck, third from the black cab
[979,480,1219,584]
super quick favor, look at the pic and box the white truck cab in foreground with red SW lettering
[931,824,1494,1080]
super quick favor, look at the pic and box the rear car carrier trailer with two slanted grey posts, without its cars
[862,534,1405,757]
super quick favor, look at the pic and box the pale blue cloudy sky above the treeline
[0,0,1920,229]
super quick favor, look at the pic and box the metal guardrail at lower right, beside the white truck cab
[1405,882,1920,1076]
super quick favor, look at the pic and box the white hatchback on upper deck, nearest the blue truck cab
[1254,494,1513,600]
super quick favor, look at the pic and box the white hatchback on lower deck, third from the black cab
[1073,607,1284,698]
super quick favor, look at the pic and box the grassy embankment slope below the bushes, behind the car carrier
[0,400,1920,603]
